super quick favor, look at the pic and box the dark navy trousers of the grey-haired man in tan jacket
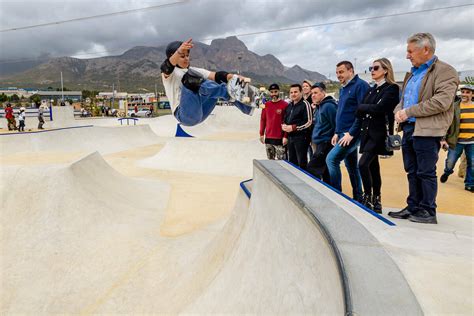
[402,124,441,216]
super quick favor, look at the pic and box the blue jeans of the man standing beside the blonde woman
[326,134,362,200]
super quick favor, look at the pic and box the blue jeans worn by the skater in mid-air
[174,80,253,126]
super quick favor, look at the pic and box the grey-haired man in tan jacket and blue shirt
[388,33,459,224]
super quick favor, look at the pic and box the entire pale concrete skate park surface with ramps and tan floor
[0,107,474,315]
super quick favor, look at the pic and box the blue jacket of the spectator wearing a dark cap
[311,96,337,144]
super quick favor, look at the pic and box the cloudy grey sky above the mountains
[0,0,474,79]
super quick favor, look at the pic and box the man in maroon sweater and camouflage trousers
[260,83,288,160]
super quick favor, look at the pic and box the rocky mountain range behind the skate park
[0,37,326,92]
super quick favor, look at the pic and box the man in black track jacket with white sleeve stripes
[281,83,313,170]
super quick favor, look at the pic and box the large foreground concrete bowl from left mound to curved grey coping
[0,153,422,315]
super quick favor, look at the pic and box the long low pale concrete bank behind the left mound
[0,125,161,155]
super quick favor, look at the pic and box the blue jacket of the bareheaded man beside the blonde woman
[336,75,369,137]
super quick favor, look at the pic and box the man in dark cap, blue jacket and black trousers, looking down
[308,82,337,184]
